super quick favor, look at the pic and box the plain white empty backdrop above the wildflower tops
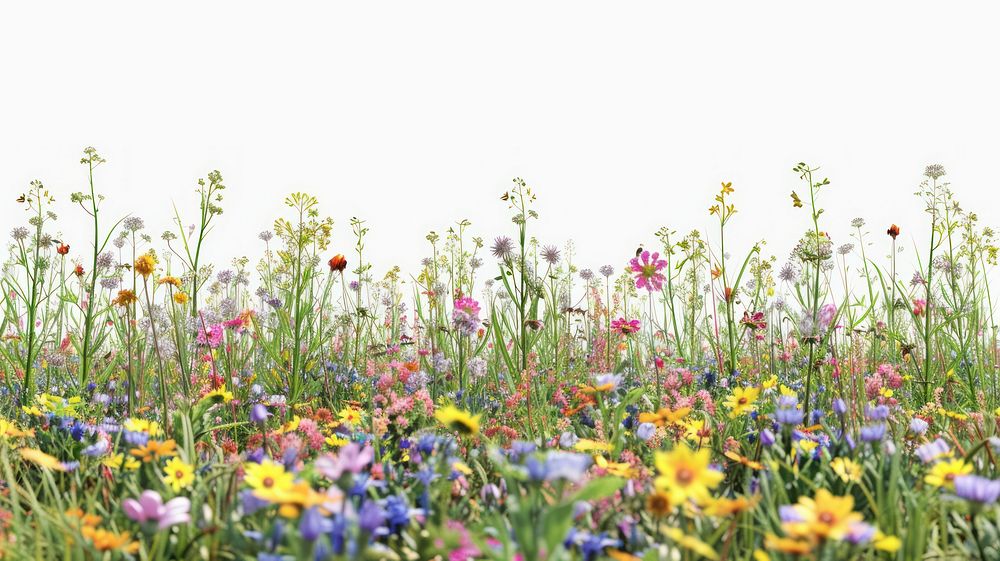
[0,2,1000,284]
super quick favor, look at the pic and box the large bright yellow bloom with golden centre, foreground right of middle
[656,444,724,504]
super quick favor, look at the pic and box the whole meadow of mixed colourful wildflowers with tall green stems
[0,153,1000,561]
